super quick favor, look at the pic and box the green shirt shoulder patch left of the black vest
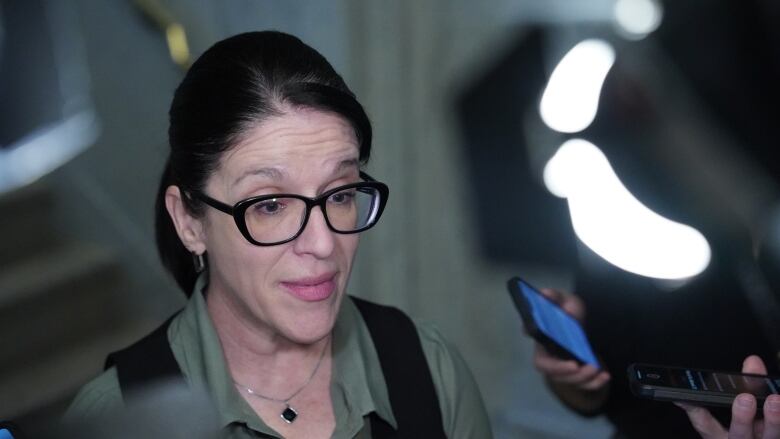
[65,367,123,421]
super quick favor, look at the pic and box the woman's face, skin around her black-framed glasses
[201,109,360,343]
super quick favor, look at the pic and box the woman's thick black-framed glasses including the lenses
[191,172,390,246]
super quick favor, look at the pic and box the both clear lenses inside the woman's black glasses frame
[244,187,381,243]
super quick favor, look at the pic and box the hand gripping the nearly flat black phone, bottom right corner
[677,355,780,439]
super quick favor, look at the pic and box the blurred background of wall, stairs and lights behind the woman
[0,0,780,438]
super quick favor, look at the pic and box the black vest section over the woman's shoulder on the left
[105,313,184,399]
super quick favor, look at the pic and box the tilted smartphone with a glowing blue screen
[507,277,602,369]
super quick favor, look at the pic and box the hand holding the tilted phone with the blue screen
[534,288,610,391]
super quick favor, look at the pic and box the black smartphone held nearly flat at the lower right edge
[628,364,780,407]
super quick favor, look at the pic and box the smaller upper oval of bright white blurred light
[539,39,615,133]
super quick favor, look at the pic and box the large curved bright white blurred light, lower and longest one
[544,139,711,279]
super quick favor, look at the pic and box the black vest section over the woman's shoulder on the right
[351,297,447,439]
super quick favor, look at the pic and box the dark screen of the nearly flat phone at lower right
[634,366,780,399]
